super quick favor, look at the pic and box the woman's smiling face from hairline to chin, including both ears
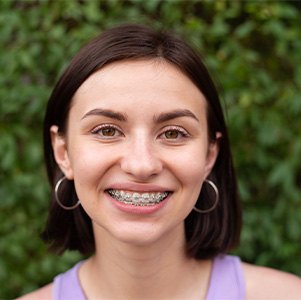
[51,60,218,245]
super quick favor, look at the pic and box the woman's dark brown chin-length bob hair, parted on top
[42,24,241,259]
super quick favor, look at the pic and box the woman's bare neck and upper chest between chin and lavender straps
[80,224,211,299]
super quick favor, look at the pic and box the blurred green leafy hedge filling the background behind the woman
[0,0,301,299]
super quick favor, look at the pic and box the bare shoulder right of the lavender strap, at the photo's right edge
[243,263,301,300]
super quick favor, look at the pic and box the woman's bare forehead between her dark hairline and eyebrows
[72,59,206,117]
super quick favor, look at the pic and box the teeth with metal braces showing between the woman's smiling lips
[107,189,169,206]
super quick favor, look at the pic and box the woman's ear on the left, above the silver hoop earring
[50,125,73,180]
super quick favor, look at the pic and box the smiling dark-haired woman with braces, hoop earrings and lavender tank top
[19,25,301,299]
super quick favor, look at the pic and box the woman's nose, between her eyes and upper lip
[121,137,163,181]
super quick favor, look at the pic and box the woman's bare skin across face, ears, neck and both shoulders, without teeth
[19,60,301,299]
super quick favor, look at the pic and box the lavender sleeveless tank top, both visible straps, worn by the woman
[53,255,246,300]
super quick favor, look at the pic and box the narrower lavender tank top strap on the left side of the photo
[53,262,86,300]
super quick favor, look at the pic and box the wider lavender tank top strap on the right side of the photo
[206,255,246,300]
